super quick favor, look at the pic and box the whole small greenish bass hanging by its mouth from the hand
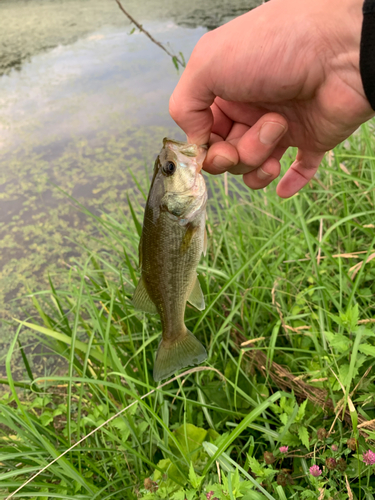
[132,138,207,381]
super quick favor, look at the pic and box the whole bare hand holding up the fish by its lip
[170,0,375,198]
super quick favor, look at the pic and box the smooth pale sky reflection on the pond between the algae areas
[0,22,205,149]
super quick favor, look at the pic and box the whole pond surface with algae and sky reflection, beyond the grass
[0,0,260,375]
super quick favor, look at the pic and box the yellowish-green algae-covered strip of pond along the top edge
[0,0,261,75]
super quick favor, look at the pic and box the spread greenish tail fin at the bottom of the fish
[154,329,207,382]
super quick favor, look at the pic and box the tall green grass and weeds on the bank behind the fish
[0,123,375,500]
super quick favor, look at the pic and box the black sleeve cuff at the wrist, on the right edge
[359,0,375,110]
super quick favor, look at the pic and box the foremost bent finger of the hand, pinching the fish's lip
[169,35,215,144]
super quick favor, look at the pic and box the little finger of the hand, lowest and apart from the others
[276,149,325,198]
